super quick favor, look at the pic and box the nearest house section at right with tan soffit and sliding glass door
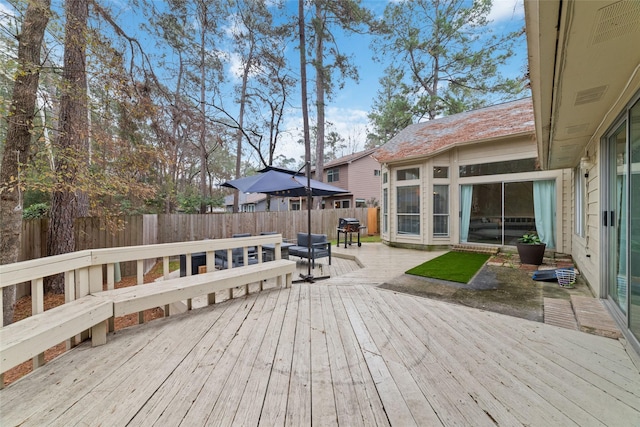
[524,0,640,354]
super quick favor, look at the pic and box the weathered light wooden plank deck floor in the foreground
[0,245,640,426]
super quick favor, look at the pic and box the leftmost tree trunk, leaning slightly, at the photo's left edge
[0,0,51,325]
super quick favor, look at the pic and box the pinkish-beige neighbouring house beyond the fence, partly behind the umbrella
[316,148,380,209]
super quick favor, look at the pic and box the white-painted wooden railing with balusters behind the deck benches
[0,234,290,382]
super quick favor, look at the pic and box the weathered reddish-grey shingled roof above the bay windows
[373,98,535,163]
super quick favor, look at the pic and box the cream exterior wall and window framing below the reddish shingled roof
[381,135,572,252]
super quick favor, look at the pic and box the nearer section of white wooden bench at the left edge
[0,295,113,373]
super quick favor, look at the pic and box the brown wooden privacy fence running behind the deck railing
[20,208,378,268]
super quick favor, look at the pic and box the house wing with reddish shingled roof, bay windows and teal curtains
[374,98,571,252]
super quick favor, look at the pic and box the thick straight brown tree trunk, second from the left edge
[46,0,89,293]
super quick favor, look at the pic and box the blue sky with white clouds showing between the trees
[0,0,527,166]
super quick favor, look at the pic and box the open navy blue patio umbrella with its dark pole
[222,166,348,282]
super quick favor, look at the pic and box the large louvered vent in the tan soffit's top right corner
[591,0,640,44]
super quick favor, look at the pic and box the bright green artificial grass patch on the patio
[406,252,491,283]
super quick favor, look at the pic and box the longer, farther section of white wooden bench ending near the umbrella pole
[93,259,296,317]
